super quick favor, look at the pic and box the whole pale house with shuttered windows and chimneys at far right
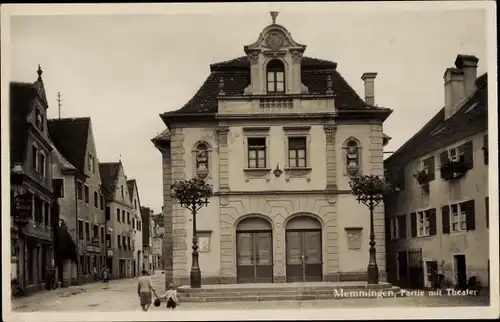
[384,55,490,288]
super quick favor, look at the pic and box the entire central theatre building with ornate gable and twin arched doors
[152,13,391,284]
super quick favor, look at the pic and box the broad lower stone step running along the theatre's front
[179,289,401,303]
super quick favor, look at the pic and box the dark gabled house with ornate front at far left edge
[10,66,57,292]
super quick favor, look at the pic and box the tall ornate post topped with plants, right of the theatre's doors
[349,175,391,284]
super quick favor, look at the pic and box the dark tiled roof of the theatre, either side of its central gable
[165,56,367,115]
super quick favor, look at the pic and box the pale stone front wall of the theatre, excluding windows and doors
[163,117,385,283]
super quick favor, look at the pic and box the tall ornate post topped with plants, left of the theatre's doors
[170,178,213,288]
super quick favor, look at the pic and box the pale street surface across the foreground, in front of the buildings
[9,273,489,312]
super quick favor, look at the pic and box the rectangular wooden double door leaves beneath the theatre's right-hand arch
[286,230,323,282]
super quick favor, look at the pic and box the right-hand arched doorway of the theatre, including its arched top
[285,216,323,282]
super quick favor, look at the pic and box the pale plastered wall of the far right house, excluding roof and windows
[389,133,489,285]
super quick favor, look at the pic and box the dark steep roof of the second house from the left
[47,117,90,173]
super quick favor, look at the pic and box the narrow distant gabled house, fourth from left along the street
[127,179,144,276]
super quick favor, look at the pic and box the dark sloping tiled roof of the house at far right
[384,73,488,167]
